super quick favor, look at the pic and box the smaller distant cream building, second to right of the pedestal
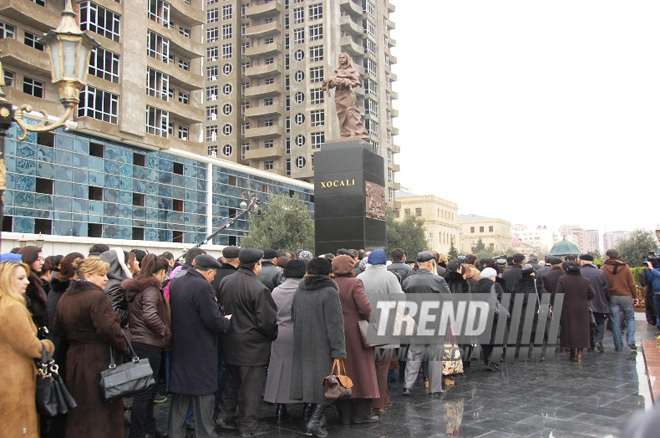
[457,215,512,254]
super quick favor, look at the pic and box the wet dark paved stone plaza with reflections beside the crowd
[144,313,657,438]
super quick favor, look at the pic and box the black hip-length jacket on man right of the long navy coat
[220,268,277,366]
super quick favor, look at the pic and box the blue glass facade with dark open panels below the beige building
[3,126,314,245]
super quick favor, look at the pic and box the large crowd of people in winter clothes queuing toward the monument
[0,241,660,438]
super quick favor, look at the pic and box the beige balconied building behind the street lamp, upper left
[0,0,205,154]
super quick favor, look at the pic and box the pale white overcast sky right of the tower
[392,0,660,233]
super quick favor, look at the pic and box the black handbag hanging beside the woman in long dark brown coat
[99,331,156,402]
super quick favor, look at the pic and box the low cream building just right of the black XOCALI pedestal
[394,192,460,253]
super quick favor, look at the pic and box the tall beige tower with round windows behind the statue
[204,0,399,202]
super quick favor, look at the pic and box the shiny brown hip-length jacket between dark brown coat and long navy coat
[121,276,172,350]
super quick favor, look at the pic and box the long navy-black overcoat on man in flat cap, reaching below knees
[170,268,230,395]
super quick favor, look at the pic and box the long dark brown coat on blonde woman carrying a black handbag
[53,281,128,438]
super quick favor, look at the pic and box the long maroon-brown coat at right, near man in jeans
[556,274,596,348]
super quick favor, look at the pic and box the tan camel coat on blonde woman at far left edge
[0,296,54,438]
